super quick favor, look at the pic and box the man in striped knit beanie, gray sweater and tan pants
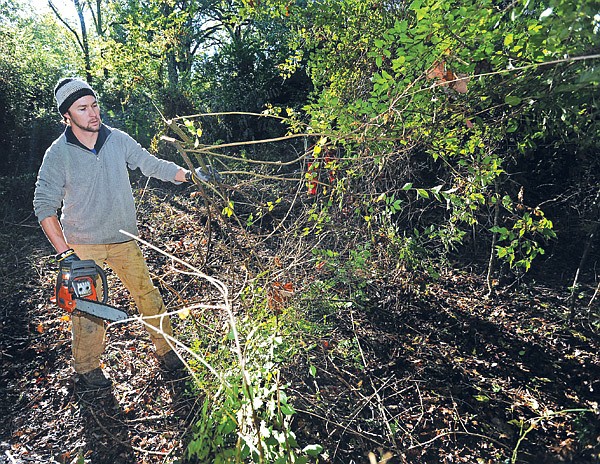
[33,78,205,388]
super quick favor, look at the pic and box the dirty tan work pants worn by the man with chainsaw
[71,240,173,374]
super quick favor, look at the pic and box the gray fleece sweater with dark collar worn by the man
[33,126,180,245]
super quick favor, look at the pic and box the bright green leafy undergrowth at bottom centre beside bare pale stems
[187,288,323,464]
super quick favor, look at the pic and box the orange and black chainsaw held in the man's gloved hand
[51,259,128,322]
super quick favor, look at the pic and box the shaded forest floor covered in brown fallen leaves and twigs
[0,186,600,464]
